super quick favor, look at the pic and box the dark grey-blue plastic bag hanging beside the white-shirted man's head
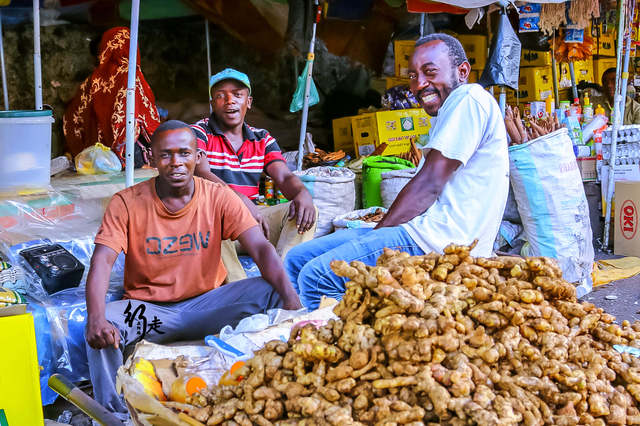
[479,13,521,90]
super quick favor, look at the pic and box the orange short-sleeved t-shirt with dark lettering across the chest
[95,177,257,302]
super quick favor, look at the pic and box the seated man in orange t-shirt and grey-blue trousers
[86,121,302,418]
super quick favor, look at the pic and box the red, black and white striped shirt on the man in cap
[191,114,284,199]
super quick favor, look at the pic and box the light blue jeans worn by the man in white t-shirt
[284,226,424,310]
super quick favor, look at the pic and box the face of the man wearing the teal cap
[211,80,252,130]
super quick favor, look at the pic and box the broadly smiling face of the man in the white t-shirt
[409,40,471,117]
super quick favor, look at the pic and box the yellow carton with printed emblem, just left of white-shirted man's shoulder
[351,108,431,157]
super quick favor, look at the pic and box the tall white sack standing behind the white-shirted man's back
[509,128,594,297]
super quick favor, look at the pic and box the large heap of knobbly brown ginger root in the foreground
[171,241,640,426]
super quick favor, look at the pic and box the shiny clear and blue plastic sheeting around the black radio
[0,191,124,405]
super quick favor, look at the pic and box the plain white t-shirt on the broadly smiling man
[402,84,509,256]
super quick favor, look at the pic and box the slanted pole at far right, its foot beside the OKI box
[602,1,625,250]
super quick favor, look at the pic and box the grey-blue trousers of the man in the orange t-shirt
[86,277,282,414]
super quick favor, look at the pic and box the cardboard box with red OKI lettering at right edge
[613,182,640,256]
